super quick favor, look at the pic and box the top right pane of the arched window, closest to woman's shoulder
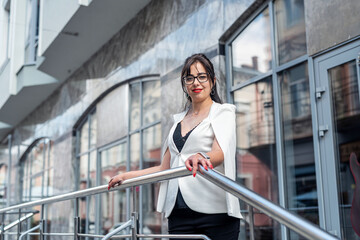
[143,81,161,126]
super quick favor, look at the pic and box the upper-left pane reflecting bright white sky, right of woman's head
[231,8,272,85]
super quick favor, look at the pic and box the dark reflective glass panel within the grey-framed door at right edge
[329,61,360,239]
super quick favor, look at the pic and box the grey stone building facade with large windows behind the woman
[0,0,360,239]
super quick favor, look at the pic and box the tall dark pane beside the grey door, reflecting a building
[278,63,319,239]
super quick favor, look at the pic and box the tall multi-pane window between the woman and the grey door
[227,0,310,239]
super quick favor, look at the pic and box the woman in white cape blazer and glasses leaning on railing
[108,54,241,240]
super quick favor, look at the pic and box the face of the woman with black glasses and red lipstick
[185,62,212,102]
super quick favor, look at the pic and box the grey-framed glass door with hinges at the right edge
[314,42,360,239]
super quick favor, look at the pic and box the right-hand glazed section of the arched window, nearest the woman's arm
[129,81,161,233]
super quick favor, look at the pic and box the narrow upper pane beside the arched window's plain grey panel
[130,83,140,130]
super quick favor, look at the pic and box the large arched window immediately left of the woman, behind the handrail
[77,79,161,234]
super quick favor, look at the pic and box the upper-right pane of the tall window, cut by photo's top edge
[275,0,306,65]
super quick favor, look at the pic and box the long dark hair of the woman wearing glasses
[181,53,222,103]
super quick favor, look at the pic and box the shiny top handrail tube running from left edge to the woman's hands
[0,167,191,213]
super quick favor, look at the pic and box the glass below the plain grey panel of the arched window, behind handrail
[100,143,127,234]
